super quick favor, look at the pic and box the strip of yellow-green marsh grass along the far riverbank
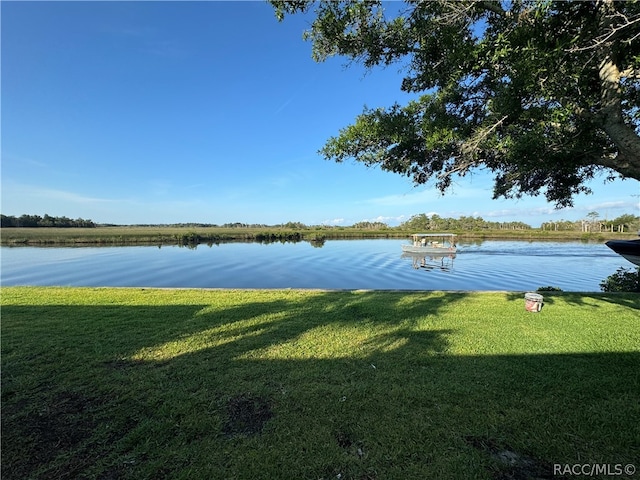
[0,226,637,246]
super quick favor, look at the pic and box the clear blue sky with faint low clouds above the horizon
[0,1,640,226]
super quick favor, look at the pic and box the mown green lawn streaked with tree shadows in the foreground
[1,287,640,480]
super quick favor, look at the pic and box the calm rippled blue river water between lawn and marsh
[0,239,633,291]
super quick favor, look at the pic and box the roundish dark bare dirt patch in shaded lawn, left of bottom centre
[222,394,272,437]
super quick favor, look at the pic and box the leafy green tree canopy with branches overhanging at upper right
[271,0,640,207]
